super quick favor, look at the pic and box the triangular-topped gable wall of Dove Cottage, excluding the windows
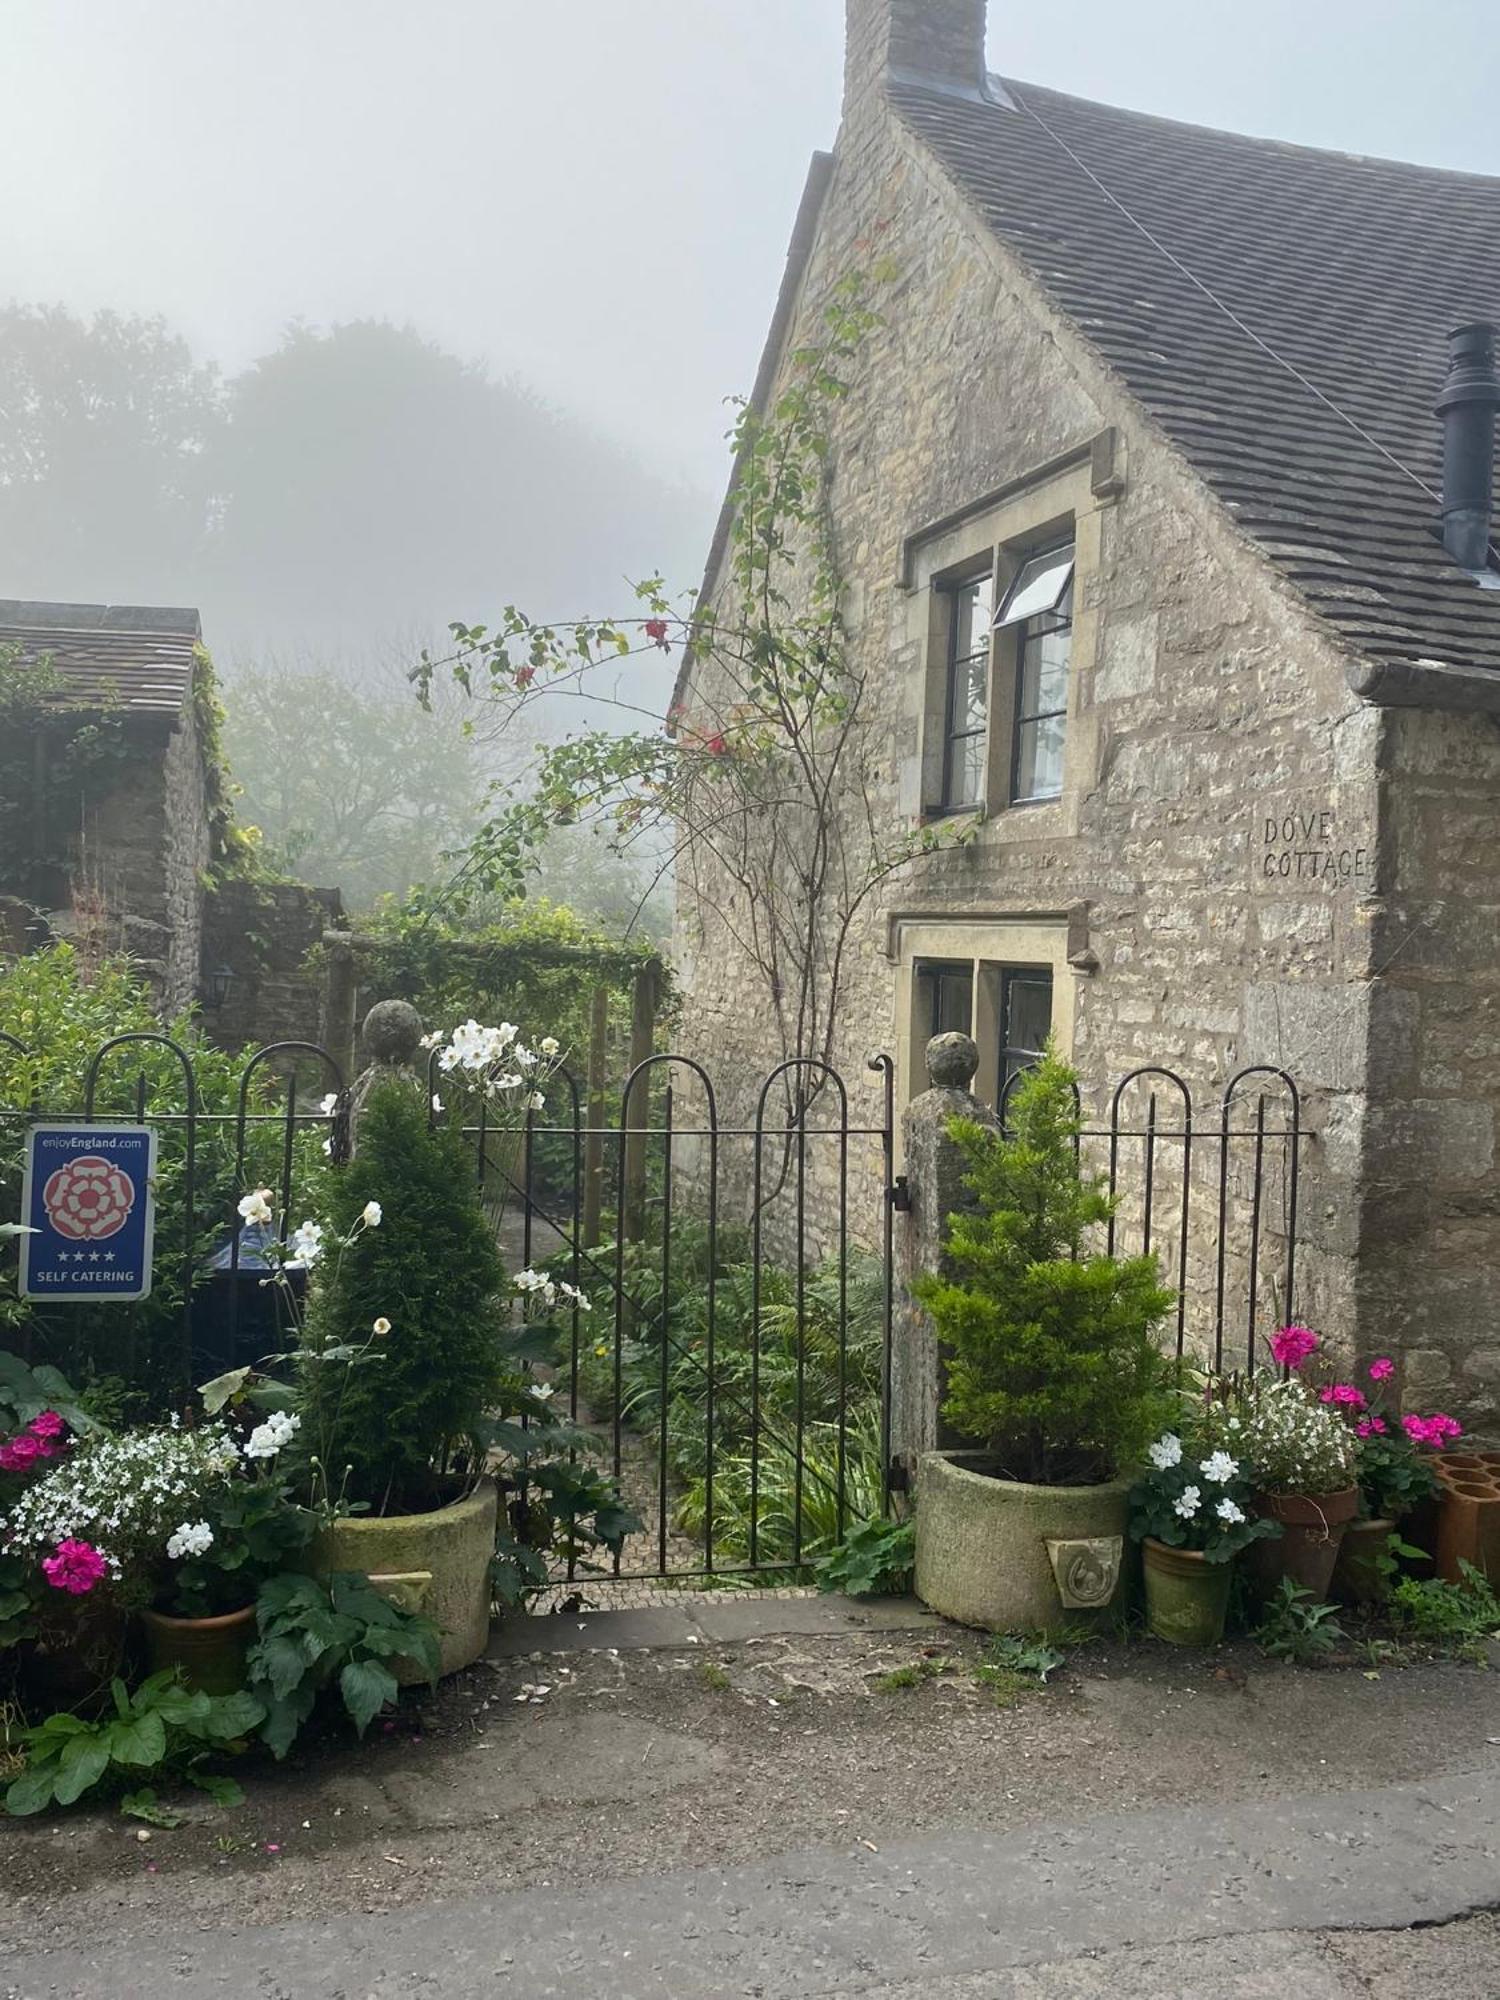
[678,58,1378,1376]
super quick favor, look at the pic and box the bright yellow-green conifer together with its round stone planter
[914,1052,1172,1630]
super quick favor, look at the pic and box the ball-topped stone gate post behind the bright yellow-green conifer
[890,1034,998,1478]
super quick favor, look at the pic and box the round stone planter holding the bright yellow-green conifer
[916,1452,1132,1632]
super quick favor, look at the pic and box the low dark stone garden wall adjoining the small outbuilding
[202,882,344,1048]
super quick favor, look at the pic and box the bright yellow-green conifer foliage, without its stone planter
[914,1052,1172,1484]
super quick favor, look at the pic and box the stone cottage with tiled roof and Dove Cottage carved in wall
[678,0,1500,1420]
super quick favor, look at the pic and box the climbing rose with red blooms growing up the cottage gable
[414,276,966,1088]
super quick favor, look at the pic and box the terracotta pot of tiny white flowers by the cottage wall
[1218,1326,1360,1598]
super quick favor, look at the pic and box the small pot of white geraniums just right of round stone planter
[1130,1424,1280,1646]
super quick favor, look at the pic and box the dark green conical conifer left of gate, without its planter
[302,1080,504,1512]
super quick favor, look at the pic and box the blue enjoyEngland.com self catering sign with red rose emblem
[20,1126,156,1300]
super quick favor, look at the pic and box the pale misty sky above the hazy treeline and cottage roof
[0,0,1500,500]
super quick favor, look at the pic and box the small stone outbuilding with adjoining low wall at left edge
[0,598,342,1048]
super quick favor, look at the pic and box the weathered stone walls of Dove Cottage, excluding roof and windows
[678,0,1500,1424]
